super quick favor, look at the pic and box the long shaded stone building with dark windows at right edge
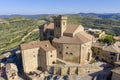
[92,42,120,63]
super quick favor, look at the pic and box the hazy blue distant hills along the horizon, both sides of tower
[0,13,120,20]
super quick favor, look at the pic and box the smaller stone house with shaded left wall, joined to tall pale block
[38,41,57,71]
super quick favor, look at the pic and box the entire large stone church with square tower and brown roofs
[40,15,93,64]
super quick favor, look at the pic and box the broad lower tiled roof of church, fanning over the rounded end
[53,32,92,44]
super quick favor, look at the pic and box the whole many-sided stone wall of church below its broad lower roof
[53,42,92,64]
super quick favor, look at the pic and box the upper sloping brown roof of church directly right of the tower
[64,24,79,34]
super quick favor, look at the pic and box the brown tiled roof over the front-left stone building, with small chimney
[20,40,55,51]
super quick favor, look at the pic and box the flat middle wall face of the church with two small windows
[62,44,80,63]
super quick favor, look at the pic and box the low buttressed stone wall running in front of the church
[48,64,103,75]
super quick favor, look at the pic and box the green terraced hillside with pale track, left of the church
[0,17,44,53]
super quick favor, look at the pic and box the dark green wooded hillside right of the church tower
[68,15,120,35]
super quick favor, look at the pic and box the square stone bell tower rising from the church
[54,15,67,37]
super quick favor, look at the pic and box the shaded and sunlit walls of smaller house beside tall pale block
[38,49,57,71]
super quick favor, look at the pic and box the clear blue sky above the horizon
[0,0,120,15]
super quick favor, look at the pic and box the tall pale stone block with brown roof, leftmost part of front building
[20,41,40,73]
